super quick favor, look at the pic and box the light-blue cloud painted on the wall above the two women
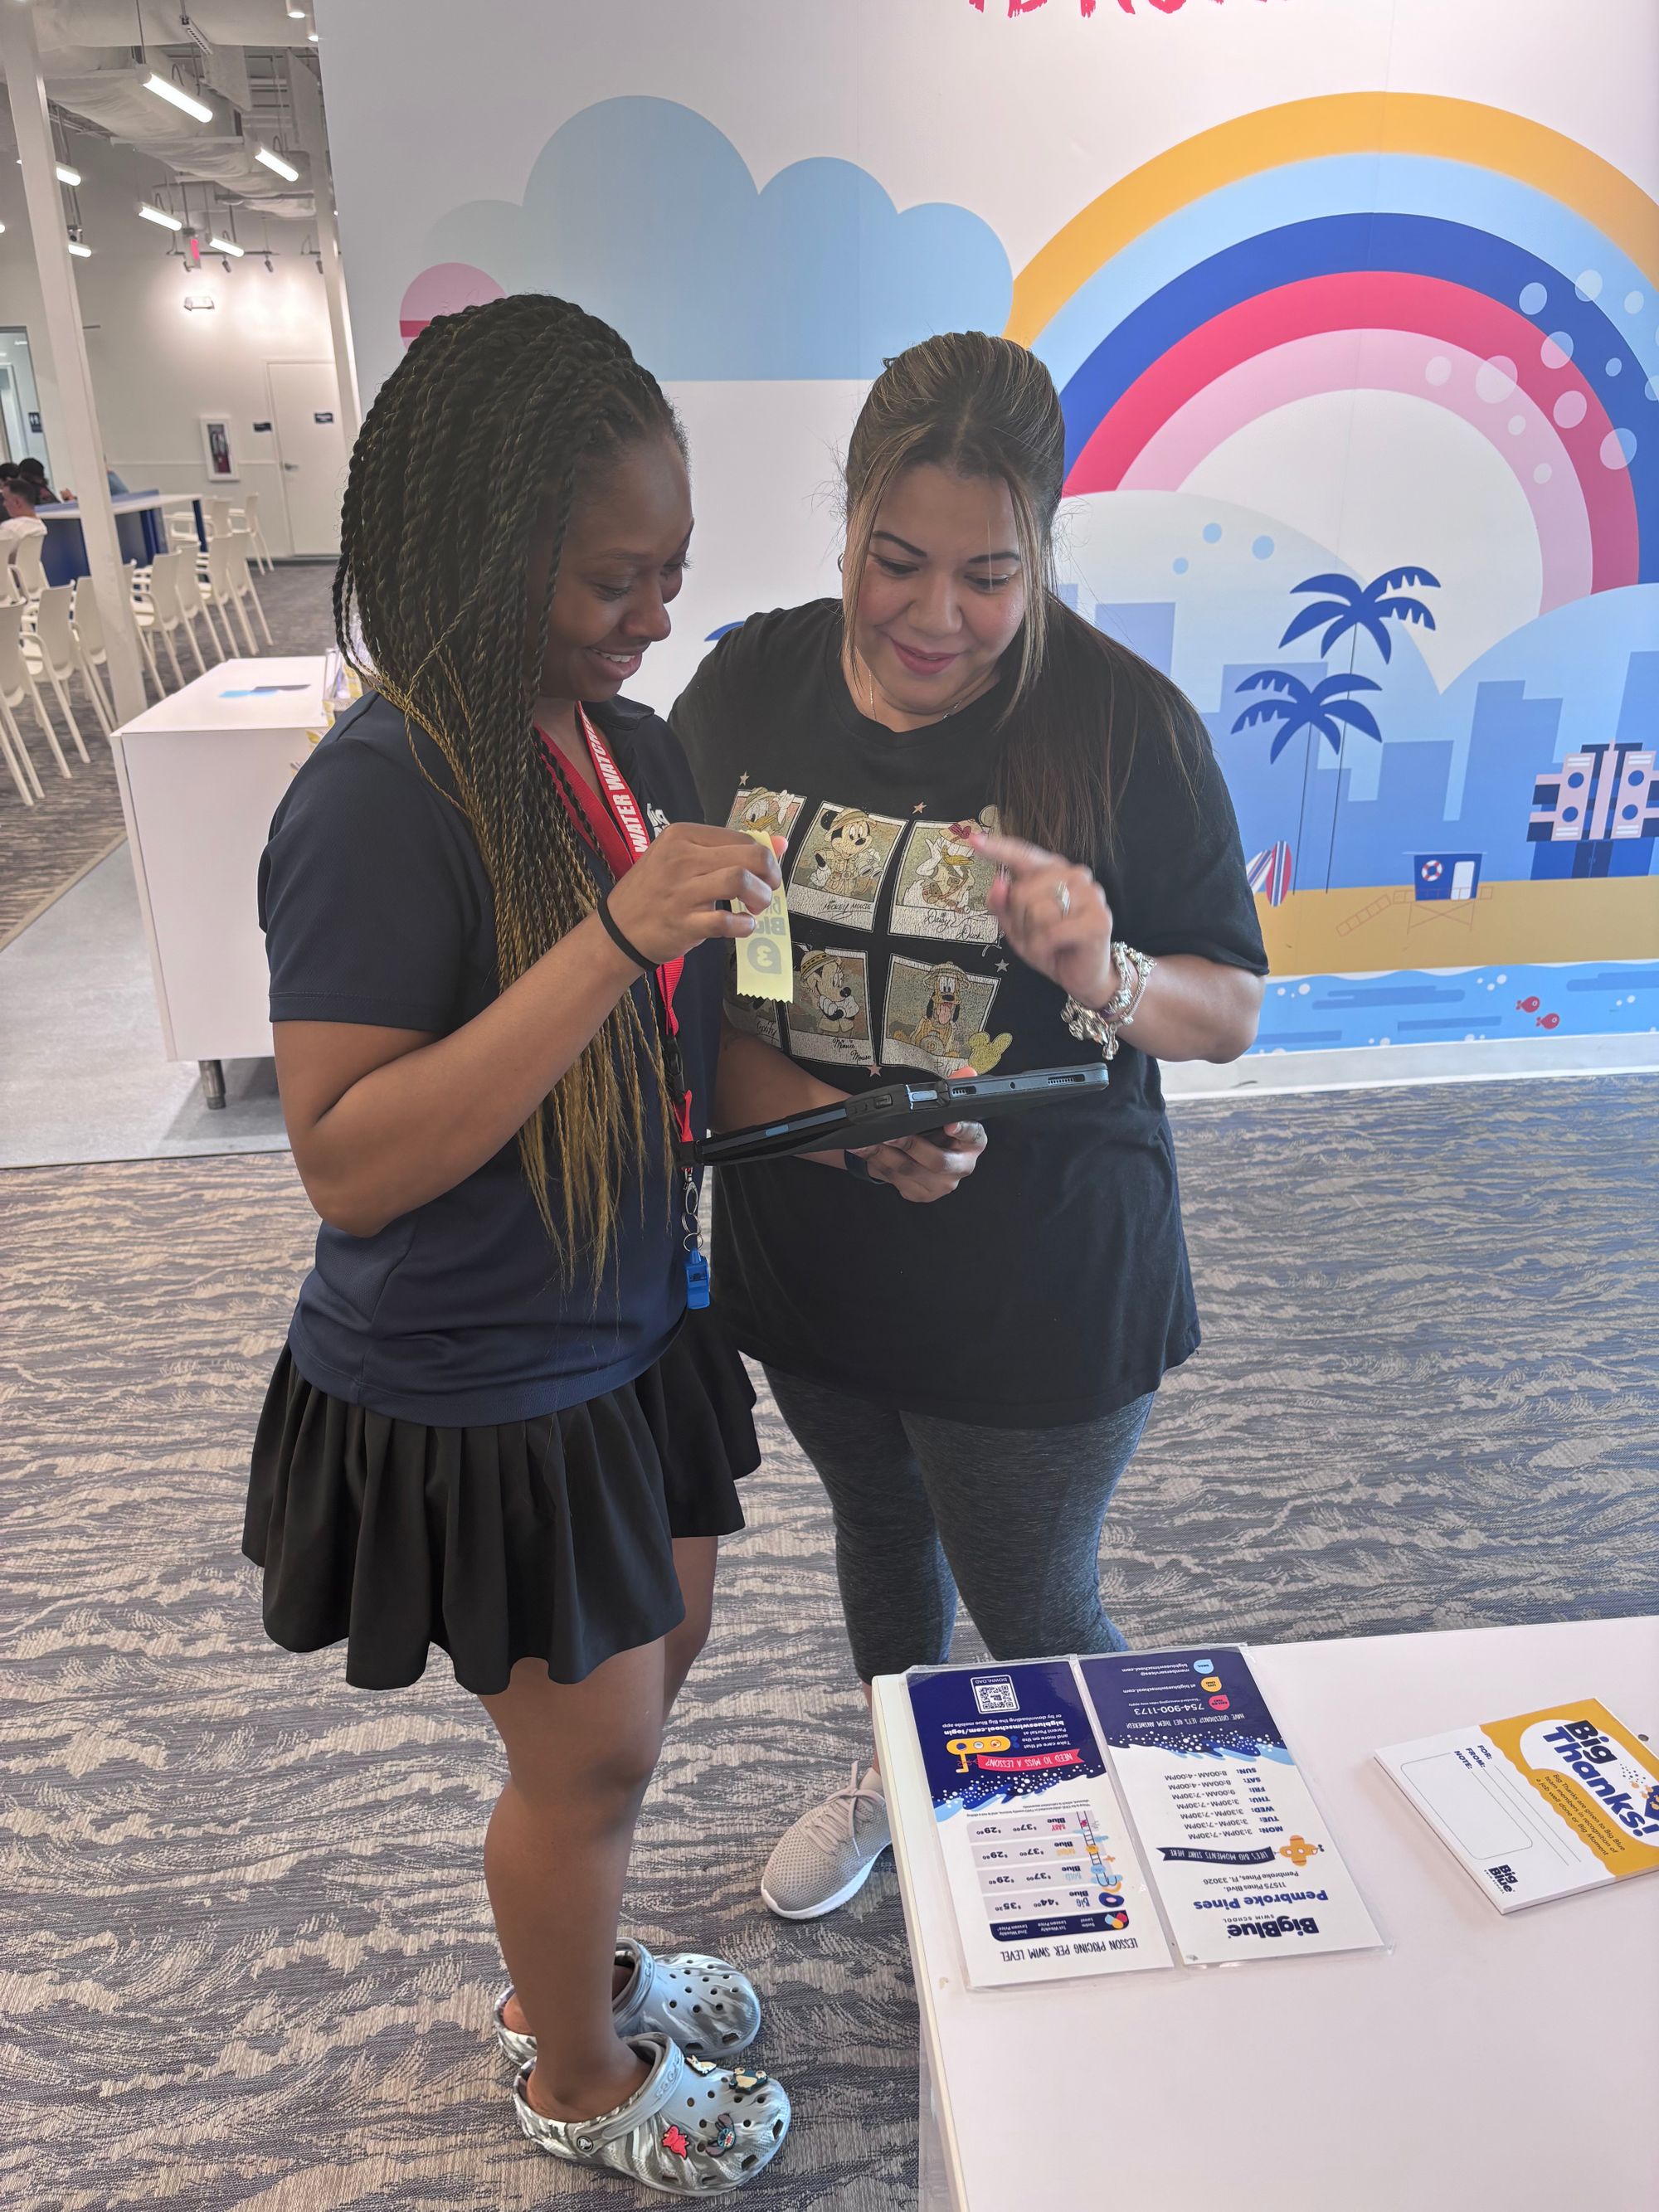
[427,97,1013,381]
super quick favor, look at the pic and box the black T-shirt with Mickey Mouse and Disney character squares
[670,600,1267,1429]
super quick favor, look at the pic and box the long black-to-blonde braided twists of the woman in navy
[334,292,686,1267]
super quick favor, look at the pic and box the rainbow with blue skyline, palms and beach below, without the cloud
[1006,93,1659,1048]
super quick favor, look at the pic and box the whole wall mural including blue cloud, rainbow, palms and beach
[401,90,1659,1051]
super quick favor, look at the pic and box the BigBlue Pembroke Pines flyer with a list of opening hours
[1078,1644,1383,1966]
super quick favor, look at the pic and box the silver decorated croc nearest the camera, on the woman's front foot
[513,2035,790,2196]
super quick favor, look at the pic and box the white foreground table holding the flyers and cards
[876,1619,1659,2212]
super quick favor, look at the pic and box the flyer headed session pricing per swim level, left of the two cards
[909,1659,1170,1986]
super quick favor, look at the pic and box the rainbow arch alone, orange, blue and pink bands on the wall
[1009,93,1659,610]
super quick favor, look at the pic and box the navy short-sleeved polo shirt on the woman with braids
[259,693,723,1427]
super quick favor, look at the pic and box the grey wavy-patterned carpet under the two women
[0,1077,1659,2212]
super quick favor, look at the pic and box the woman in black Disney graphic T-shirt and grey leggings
[670,332,1267,1920]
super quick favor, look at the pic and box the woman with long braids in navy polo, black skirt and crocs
[243,296,973,2195]
